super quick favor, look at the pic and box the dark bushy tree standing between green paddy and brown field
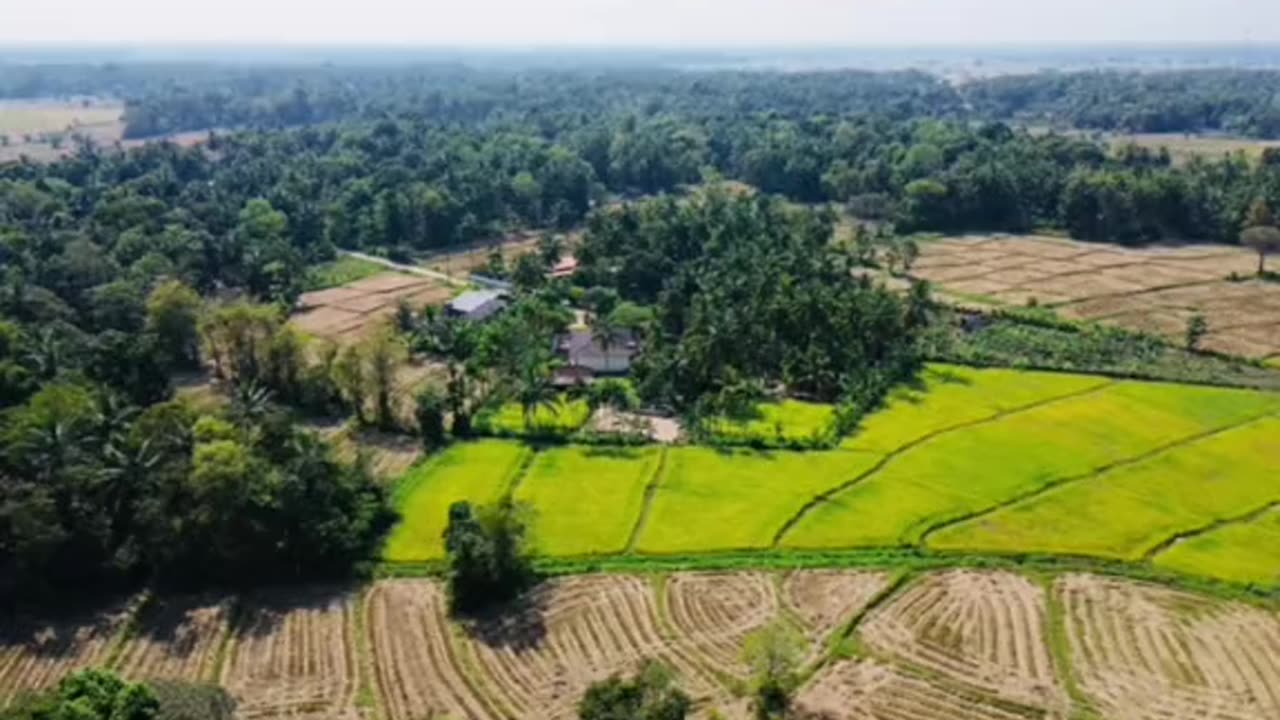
[444,501,534,614]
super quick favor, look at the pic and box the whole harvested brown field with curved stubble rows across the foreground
[0,570,1280,720]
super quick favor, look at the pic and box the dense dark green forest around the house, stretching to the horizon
[0,58,1280,609]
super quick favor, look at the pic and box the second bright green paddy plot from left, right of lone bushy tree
[516,446,662,556]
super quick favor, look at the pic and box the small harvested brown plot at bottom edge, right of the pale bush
[796,660,1056,720]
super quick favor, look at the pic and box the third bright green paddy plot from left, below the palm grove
[636,447,879,553]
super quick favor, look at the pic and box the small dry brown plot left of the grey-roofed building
[292,272,456,343]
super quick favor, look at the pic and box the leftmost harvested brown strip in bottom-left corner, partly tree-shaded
[0,599,132,707]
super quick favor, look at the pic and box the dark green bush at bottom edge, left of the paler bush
[577,661,694,720]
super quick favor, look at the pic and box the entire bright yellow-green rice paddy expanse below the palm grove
[385,366,1280,587]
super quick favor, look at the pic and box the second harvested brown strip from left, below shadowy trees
[116,598,232,682]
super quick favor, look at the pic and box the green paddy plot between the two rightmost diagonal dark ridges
[928,412,1280,560]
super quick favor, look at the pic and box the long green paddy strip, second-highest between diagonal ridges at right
[782,383,1274,548]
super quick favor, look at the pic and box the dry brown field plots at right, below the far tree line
[911,236,1280,357]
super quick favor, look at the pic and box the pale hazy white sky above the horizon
[0,0,1280,46]
